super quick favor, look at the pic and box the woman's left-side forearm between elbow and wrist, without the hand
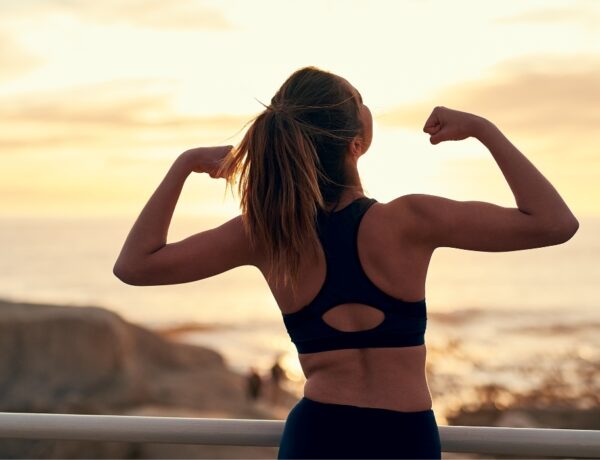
[115,157,192,271]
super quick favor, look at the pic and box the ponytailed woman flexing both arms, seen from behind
[114,67,578,458]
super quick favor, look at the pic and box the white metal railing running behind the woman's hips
[0,412,600,458]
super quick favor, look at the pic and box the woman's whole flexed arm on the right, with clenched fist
[399,107,579,251]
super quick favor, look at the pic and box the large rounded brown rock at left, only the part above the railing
[0,302,234,412]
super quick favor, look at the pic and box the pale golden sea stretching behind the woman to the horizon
[0,215,600,421]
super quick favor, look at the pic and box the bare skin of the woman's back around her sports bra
[254,196,432,412]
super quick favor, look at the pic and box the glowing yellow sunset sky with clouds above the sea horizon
[0,0,600,217]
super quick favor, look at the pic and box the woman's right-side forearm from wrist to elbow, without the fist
[474,118,577,225]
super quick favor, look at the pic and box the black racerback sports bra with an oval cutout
[283,197,427,353]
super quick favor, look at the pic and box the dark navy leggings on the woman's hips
[277,397,442,459]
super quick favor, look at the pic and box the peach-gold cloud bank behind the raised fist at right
[377,55,600,157]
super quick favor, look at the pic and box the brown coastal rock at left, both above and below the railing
[0,301,297,458]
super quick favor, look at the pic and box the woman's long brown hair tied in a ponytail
[220,67,363,288]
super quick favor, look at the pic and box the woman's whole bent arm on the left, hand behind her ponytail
[113,146,255,286]
